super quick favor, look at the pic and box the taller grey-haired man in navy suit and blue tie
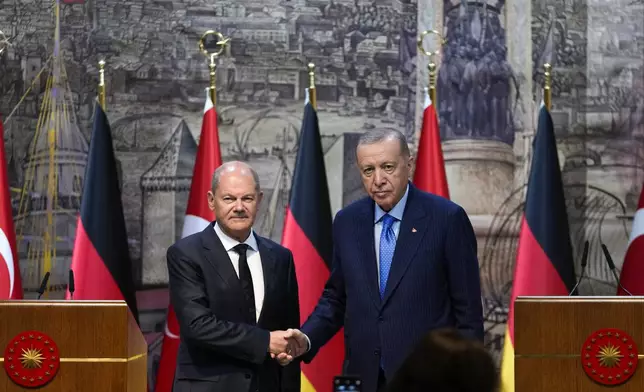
[278,130,483,392]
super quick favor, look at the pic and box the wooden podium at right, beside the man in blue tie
[514,296,644,392]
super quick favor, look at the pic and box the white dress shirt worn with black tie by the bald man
[215,222,264,321]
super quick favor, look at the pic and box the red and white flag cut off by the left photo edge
[0,118,22,299]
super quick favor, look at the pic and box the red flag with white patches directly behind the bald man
[154,92,221,392]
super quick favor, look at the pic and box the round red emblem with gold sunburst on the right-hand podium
[581,328,638,385]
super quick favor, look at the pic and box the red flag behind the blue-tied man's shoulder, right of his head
[414,91,449,199]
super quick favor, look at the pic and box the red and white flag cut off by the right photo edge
[617,188,644,295]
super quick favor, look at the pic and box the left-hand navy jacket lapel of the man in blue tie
[353,198,380,308]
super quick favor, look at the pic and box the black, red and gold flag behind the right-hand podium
[501,105,575,392]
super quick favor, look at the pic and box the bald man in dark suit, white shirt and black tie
[167,162,300,392]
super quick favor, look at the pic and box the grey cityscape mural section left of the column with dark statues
[0,0,417,386]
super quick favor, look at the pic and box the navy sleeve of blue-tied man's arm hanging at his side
[445,207,484,341]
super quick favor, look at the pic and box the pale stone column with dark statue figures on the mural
[416,0,532,216]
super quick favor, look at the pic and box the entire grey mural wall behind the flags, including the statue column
[0,0,644,386]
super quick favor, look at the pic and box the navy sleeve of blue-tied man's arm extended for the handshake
[302,216,346,363]
